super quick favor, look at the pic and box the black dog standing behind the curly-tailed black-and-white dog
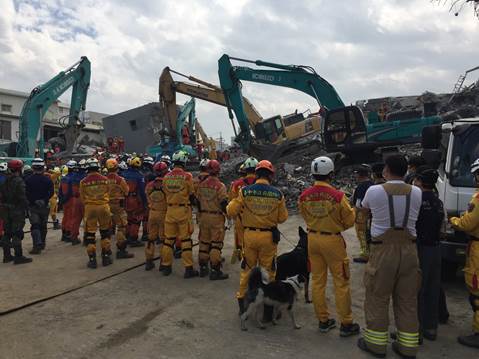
[275,227,311,303]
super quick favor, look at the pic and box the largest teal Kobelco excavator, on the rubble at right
[218,54,441,161]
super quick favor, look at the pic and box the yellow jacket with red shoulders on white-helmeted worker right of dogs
[298,181,355,233]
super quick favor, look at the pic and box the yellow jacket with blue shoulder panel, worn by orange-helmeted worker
[226,179,288,229]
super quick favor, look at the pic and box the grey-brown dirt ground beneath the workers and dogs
[0,216,479,359]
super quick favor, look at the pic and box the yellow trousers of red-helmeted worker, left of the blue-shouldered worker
[198,213,225,268]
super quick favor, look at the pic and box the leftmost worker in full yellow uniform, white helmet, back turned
[80,158,113,269]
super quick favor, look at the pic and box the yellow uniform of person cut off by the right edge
[450,192,479,333]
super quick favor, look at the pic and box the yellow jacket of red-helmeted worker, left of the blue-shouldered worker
[197,176,228,214]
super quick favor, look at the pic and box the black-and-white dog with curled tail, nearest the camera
[241,267,304,330]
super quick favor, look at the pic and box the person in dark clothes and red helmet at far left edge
[0,160,32,264]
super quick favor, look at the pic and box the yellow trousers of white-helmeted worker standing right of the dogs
[308,233,353,325]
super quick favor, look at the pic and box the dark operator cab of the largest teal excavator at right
[322,106,367,152]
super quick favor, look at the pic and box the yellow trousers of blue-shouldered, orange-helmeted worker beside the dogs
[236,230,278,298]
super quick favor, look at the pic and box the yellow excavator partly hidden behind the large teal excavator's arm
[159,67,321,157]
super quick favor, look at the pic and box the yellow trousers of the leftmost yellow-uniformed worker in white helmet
[83,204,111,255]
